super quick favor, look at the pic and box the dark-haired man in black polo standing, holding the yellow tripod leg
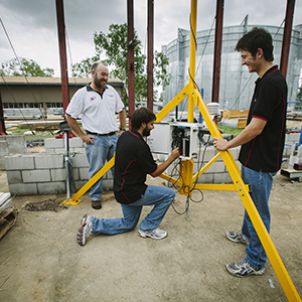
[215,28,287,277]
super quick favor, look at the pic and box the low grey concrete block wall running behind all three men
[4,133,299,195]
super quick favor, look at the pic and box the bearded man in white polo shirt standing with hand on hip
[65,62,126,209]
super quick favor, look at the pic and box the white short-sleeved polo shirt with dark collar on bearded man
[66,85,124,134]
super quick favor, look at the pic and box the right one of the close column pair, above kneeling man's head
[147,0,154,111]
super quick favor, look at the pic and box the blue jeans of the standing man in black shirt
[241,166,276,269]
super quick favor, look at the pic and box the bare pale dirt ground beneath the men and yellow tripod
[0,171,302,302]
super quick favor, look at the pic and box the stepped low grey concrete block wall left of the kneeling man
[5,137,113,195]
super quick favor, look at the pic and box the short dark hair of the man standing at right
[235,27,274,62]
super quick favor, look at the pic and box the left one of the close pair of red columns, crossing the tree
[127,0,135,117]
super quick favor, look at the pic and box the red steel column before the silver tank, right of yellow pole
[212,0,224,103]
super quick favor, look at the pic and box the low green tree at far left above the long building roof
[0,58,54,77]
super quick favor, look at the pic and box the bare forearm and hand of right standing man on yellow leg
[214,117,267,151]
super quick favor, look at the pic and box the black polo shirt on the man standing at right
[239,66,287,172]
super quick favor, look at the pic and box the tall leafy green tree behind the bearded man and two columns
[73,24,169,102]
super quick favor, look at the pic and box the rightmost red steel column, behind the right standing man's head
[280,0,295,78]
